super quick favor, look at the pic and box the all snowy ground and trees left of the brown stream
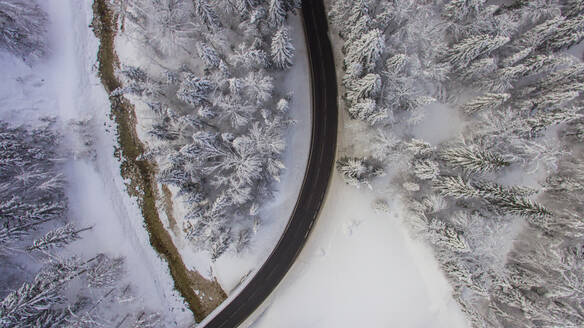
[0,0,191,328]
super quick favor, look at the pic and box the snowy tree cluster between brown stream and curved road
[112,0,300,259]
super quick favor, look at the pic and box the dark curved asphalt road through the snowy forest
[204,0,338,328]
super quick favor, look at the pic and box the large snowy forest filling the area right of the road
[329,0,584,327]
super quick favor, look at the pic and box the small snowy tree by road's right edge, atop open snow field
[337,157,383,187]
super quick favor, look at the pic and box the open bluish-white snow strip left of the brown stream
[0,0,193,327]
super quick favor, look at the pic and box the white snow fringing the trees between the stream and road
[115,15,311,295]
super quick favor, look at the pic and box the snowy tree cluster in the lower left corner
[0,119,160,328]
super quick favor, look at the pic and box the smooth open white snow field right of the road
[253,169,467,328]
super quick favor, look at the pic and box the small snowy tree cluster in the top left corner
[0,0,47,59]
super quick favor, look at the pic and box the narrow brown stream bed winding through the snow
[92,0,226,320]
